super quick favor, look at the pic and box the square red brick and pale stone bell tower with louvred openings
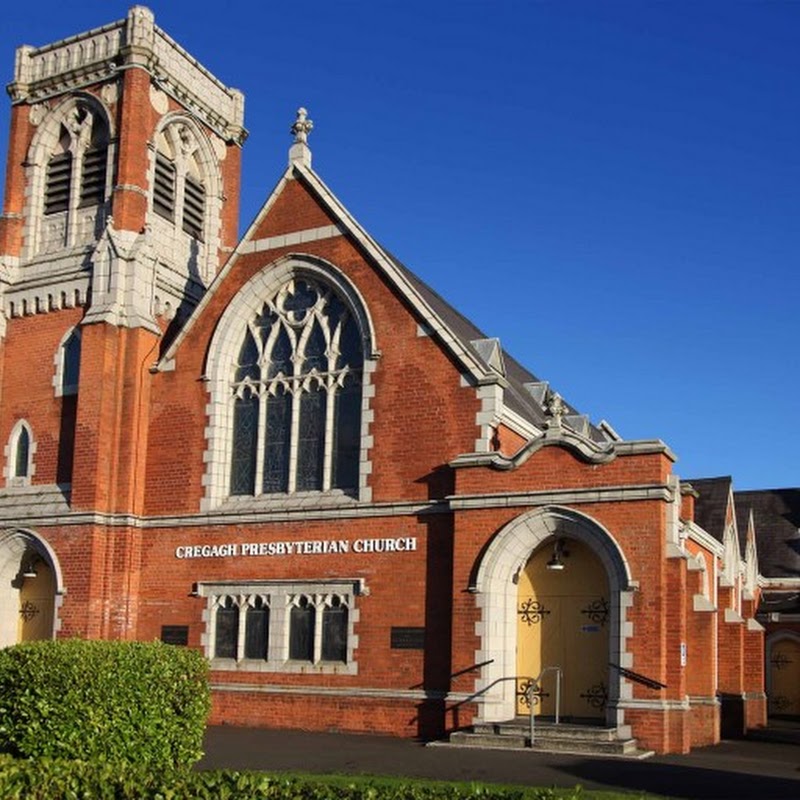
[0,6,246,514]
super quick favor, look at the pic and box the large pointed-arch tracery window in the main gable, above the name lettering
[230,277,363,495]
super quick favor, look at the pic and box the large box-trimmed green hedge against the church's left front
[0,639,210,768]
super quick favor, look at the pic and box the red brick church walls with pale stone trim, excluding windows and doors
[0,11,765,752]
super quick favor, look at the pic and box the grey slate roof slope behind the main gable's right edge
[382,248,608,442]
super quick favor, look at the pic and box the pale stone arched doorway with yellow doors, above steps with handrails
[473,506,633,726]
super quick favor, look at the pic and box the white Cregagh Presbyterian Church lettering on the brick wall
[175,536,417,559]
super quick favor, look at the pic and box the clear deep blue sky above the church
[0,0,800,489]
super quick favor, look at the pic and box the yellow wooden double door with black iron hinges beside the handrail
[517,539,609,720]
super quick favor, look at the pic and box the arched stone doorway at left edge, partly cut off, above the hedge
[0,529,62,647]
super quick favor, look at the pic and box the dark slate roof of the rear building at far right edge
[736,484,800,578]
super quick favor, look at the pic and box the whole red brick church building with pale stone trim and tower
[0,6,800,752]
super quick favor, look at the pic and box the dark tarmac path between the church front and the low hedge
[199,726,800,800]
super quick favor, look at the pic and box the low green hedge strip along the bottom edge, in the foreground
[0,756,592,800]
